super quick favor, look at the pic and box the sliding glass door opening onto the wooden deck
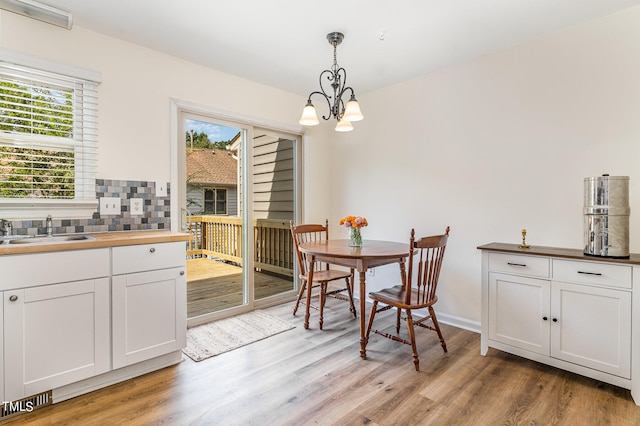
[178,111,299,325]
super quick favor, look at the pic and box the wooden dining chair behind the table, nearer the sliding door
[289,220,356,330]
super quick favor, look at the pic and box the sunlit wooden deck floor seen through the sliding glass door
[187,258,293,318]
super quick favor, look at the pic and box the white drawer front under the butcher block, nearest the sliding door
[112,242,186,275]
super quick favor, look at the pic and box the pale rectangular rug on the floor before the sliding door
[182,310,295,362]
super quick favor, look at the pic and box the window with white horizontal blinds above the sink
[0,53,97,217]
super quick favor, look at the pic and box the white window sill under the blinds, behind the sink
[0,198,98,220]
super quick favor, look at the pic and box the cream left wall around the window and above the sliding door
[0,11,304,181]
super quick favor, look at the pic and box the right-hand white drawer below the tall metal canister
[553,259,632,288]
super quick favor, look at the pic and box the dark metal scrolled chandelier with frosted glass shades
[300,32,364,132]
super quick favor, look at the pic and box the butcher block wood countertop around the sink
[0,231,191,256]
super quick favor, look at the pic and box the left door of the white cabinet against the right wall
[489,272,550,355]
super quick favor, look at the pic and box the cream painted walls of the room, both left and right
[0,8,640,325]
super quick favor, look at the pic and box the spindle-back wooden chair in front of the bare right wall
[365,226,449,371]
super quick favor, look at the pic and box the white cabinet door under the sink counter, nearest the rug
[112,268,187,369]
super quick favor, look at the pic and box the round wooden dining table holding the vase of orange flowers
[299,240,409,359]
